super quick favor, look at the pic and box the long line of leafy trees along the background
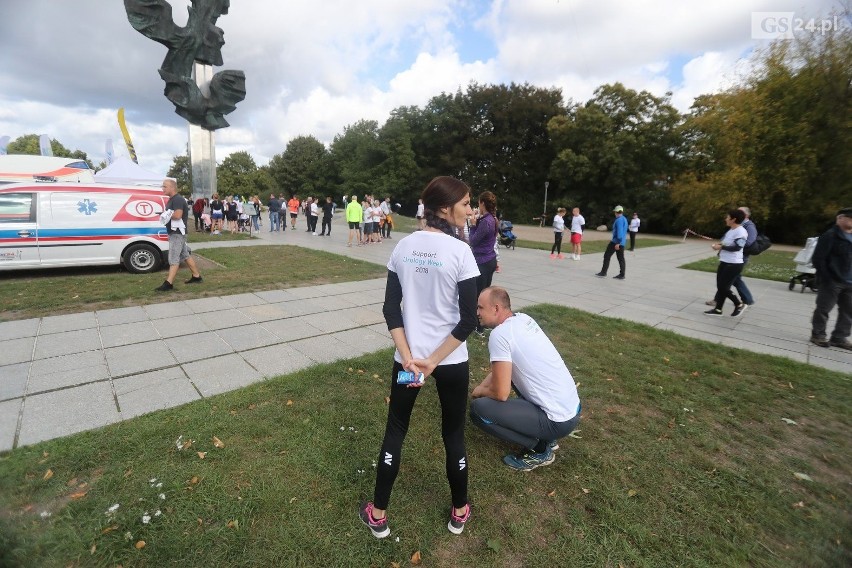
[9,19,852,244]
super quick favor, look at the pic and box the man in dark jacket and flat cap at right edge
[811,207,852,350]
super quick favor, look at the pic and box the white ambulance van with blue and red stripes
[0,181,169,273]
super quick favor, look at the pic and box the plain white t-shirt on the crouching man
[488,313,580,422]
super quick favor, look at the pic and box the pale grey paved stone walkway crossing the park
[0,219,852,451]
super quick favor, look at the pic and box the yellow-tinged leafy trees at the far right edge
[672,18,852,243]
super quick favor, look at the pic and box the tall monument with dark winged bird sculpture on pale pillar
[124,0,246,198]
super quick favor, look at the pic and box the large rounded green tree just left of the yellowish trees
[549,83,681,231]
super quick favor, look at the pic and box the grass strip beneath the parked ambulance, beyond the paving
[0,245,387,321]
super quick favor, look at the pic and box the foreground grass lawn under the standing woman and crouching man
[0,305,852,568]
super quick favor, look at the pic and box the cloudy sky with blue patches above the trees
[0,0,843,174]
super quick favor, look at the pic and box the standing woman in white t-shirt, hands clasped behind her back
[360,176,479,538]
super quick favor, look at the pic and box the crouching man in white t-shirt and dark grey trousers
[470,286,580,471]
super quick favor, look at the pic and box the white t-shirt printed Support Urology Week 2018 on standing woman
[388,231,479,365]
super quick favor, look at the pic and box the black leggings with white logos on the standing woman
[373,361,470,509]
